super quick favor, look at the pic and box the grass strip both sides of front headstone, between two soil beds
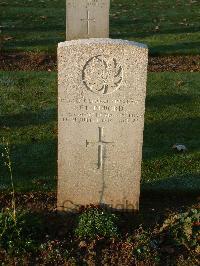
[0,72,200,194]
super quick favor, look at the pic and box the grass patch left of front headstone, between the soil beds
[0,72,57,191]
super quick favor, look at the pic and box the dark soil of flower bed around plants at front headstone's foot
[0,192,200,266]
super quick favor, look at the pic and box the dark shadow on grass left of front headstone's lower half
[0,140,57,192]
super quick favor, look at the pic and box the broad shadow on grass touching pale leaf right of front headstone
[143,117,200,159]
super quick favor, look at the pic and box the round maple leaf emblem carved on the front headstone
[82,55,123,95]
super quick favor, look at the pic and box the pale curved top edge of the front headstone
[58,38,148,49]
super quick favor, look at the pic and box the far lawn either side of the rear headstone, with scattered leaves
[0,0,200,55]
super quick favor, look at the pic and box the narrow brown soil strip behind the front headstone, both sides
[0,53,200,72]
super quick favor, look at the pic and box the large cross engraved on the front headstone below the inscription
[86,127,114,169]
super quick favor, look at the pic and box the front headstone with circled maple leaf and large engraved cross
[58,39,148,211]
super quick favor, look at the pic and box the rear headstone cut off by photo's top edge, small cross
[66,0,110,40]
